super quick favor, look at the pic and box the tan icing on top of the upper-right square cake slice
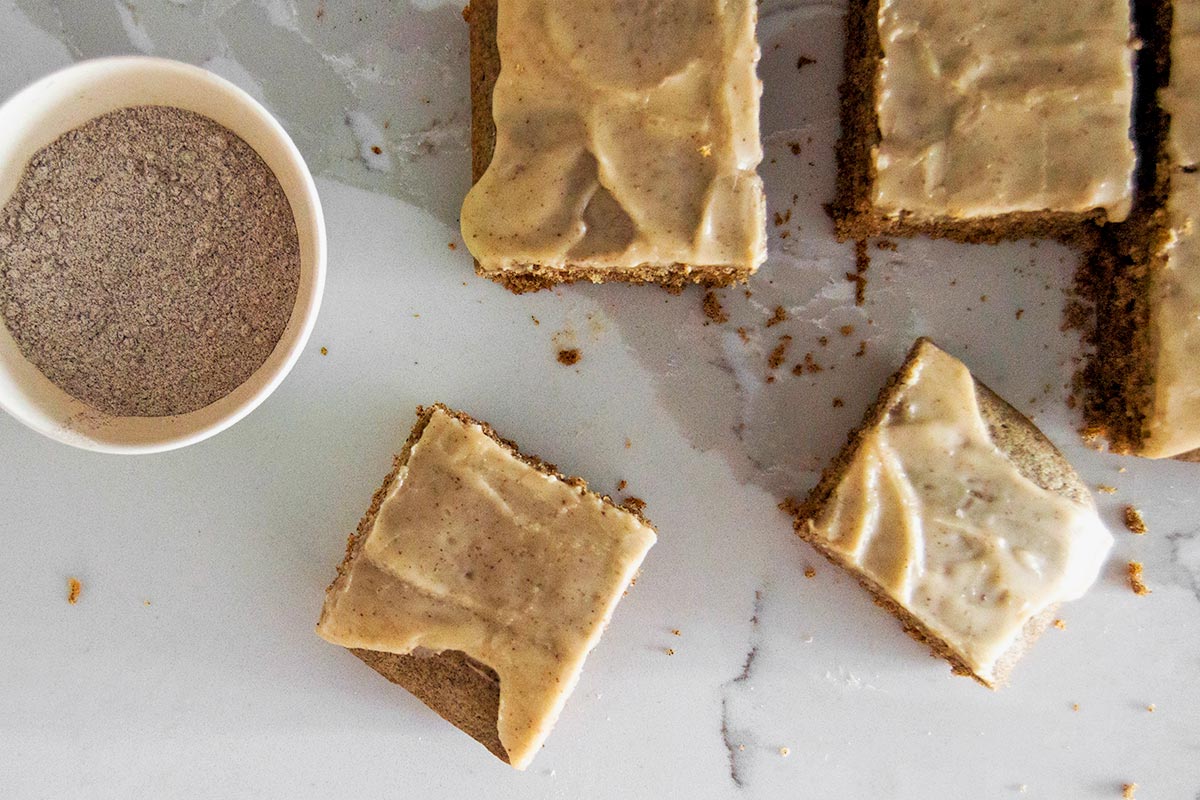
[872,0,1134,221]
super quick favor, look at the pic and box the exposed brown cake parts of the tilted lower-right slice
[794,338,1091,688]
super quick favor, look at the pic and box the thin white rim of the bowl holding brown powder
[0,55,328,455]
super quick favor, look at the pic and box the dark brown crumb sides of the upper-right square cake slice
[829,0,1105,243]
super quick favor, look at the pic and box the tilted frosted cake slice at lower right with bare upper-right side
[796,339,1112,688]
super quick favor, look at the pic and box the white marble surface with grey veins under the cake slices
[0,0,1200,800]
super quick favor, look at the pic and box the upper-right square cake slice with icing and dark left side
[832,0,1135,242]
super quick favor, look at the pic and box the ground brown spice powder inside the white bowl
[0,106,300,416]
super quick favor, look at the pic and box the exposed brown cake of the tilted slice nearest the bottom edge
[326,403,653,763]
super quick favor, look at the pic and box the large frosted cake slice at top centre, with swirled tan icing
[461,0,767,293]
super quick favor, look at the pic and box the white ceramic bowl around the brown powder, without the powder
[0,58,325,453]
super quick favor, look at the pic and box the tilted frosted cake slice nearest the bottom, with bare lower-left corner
[317,405,655,769]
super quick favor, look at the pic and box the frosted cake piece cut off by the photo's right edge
[1084,0,1200,461]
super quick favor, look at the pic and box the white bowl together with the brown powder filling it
[0,58,325,453]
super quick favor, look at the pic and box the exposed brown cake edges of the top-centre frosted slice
[462,0,754,294]
